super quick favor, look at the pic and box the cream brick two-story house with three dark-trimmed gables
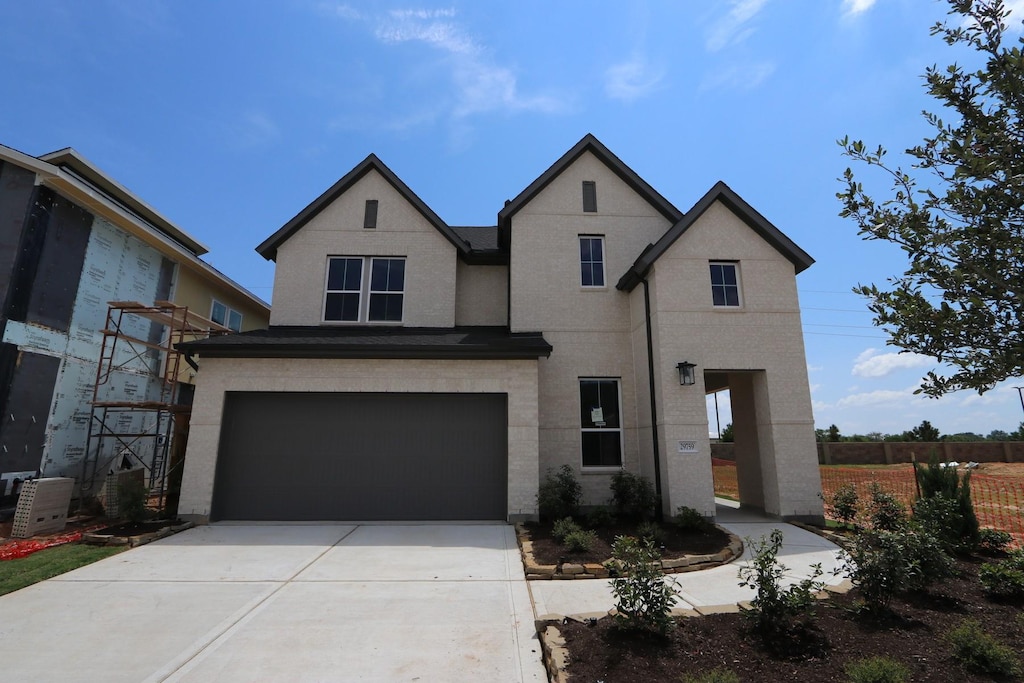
[179,135,821,520]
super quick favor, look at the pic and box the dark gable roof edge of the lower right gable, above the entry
[615,180,814,292]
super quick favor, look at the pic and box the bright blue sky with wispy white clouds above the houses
[0,0,1024,433]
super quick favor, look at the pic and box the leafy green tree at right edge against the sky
[837,0,1024,396]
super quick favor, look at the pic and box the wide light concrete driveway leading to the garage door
[0,523,547,683]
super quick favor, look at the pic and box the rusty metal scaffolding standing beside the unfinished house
[79,301,228,511]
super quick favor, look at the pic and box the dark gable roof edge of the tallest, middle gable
[498,133,683,251]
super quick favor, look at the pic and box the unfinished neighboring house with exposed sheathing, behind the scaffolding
[0,145,270,502]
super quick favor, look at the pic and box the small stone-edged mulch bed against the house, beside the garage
[525,522,729,564]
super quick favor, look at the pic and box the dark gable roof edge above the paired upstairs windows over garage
[256,154,470,261]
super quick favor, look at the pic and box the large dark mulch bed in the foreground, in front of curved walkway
[558,558,1024,683]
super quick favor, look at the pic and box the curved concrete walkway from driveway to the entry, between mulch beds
[528,499,843,618]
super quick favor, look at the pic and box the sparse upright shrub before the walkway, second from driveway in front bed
[739,528,824,641]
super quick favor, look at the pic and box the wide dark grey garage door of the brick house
[211,392,508,520]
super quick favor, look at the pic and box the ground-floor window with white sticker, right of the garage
[580,379,623,467]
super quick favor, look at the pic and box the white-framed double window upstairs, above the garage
[324,256,406,323]
